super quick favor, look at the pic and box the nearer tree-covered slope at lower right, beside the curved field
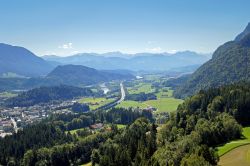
[92,83,250,166]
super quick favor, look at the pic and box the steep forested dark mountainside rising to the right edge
[175,23,250,98]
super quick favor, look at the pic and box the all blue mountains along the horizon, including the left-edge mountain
[0,43,210,77]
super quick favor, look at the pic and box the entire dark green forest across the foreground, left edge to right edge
[0,82,250,166]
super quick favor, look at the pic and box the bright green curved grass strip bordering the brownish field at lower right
[218,127,250,156]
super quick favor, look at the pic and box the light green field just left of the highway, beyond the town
[78,97,115,110]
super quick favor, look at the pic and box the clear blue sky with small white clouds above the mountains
[0,0,250,56]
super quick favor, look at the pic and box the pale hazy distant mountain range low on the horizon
[42,51,211,71]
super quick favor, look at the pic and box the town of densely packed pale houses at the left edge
[0,101,74,137]
